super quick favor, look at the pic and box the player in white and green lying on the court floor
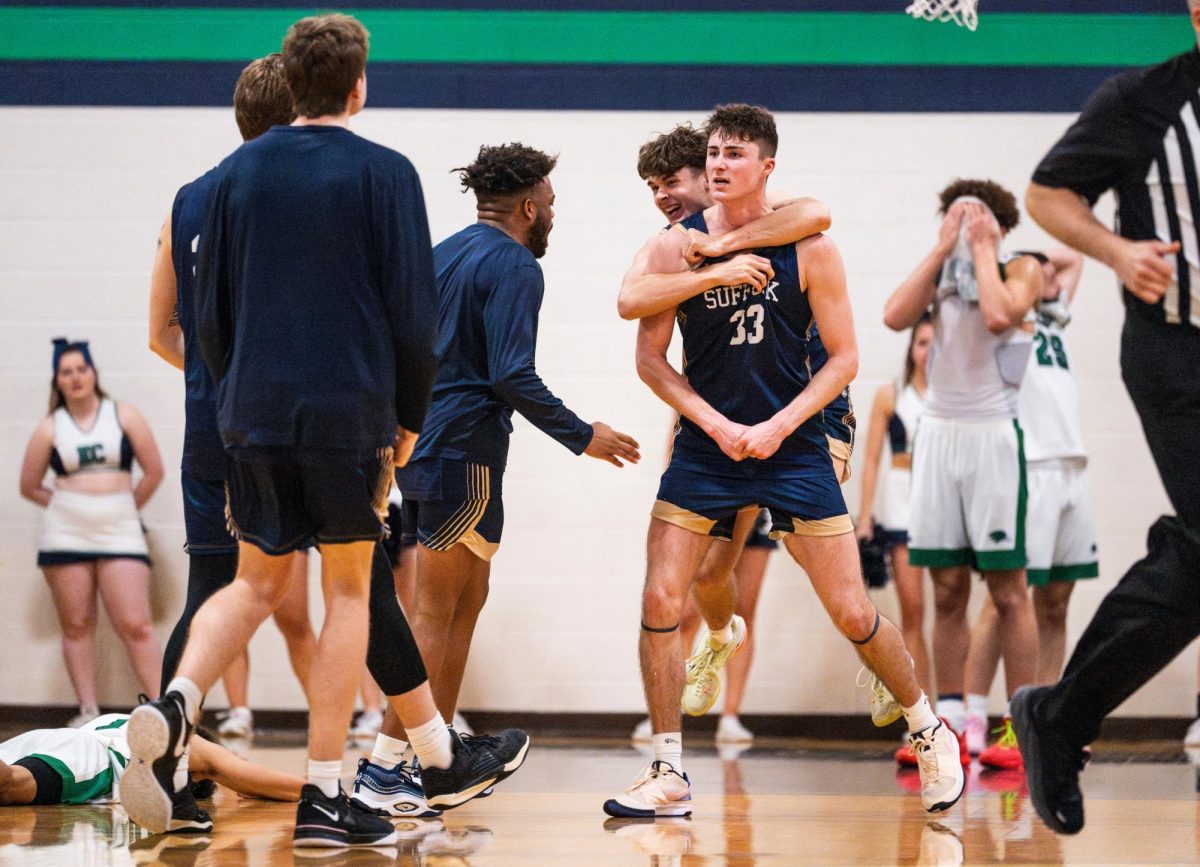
[0,713,304,811]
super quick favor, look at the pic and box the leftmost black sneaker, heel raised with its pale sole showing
[120,692,192,833]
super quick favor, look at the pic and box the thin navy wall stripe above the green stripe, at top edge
[23,0,1186,10]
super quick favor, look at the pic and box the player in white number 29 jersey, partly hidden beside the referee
[964,249,1100,770]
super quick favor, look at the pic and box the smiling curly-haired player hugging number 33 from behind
[617,124,853,743]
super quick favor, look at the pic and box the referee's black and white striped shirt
[1033,48,1200,330]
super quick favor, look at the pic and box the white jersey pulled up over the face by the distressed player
[925,279,1032,419]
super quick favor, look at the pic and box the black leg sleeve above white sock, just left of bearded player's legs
[367,545,428,695]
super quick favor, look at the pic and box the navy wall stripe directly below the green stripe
[0,61,1120,112]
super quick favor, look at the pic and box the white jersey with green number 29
[1019,313,1087,461]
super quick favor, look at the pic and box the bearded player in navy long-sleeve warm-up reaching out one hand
[384,144,640,749]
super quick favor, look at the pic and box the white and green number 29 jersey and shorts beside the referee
[1020,301,1100,585]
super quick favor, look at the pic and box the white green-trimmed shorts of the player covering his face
[908,415,1026,572]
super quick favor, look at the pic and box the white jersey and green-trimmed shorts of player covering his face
[908,253,1032,572]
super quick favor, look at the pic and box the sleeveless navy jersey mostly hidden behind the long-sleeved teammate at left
[170,171,226,482]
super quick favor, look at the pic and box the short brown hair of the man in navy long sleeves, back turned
[283,14,370,118]
